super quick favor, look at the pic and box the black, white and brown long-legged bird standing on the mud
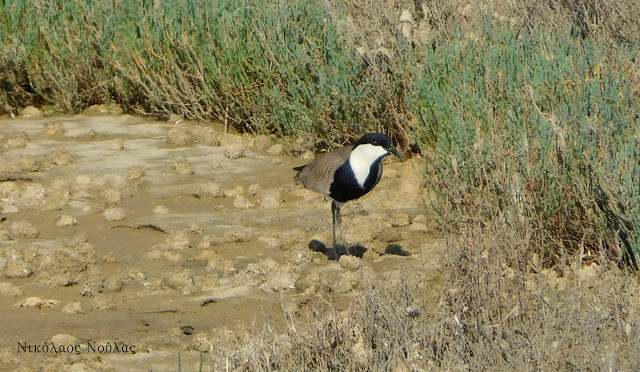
[293,133,402,254]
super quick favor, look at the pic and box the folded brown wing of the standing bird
[294,146,353,195]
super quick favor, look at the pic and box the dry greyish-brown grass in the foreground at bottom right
[202,222,640,371]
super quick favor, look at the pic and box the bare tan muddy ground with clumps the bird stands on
[0,107,440,371]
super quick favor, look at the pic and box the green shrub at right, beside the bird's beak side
[407,28,640,267]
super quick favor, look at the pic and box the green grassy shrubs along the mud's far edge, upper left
[0,0,396,142]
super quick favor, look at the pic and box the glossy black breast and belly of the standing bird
[329,159,382,203]
